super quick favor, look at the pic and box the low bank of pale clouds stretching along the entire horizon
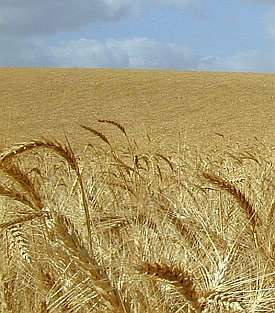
[0,37,275,72]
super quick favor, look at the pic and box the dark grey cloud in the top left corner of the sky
[0,0,133,36]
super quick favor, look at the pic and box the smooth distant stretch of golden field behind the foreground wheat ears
[0,68,275,149]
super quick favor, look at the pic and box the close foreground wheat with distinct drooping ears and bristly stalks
[0,120,275,313]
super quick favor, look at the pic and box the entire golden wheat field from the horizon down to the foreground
[0,69,275,313]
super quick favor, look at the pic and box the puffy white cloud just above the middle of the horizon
[50,38,197,69]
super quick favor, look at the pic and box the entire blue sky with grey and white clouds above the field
[0,0,275,72]
